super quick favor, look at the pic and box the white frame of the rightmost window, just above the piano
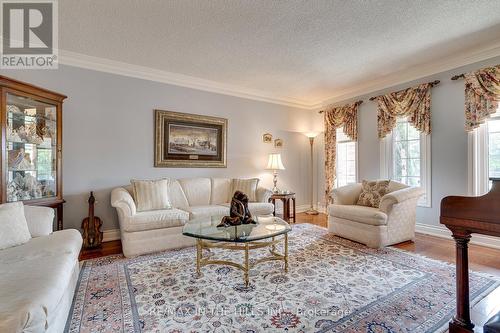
[467,106,500,196]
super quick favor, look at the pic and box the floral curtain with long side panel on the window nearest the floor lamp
[324,101,361,204]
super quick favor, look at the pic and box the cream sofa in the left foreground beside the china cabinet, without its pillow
[0,206,82,333]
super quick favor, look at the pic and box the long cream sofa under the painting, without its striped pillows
[111,178,274,257]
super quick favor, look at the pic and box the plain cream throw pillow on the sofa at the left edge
[0,202,31,250]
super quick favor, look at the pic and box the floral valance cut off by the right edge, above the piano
[464,65,500,131]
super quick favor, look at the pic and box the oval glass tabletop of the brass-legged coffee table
[182,216,292,243]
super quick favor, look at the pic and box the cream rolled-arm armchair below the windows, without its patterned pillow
[328,181,424,248]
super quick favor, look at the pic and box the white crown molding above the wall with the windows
[321,40,500,106]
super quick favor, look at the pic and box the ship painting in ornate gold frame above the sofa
[155,110,227,168]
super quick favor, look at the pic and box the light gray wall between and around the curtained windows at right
[314,57,500,225]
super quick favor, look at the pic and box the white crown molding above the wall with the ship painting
[59,49,312,109]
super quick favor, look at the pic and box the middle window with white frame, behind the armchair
[380,118,431,207]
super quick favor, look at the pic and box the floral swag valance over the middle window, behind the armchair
[375,83,433,139]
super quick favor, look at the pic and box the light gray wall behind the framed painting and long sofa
[2,66,313,230]
